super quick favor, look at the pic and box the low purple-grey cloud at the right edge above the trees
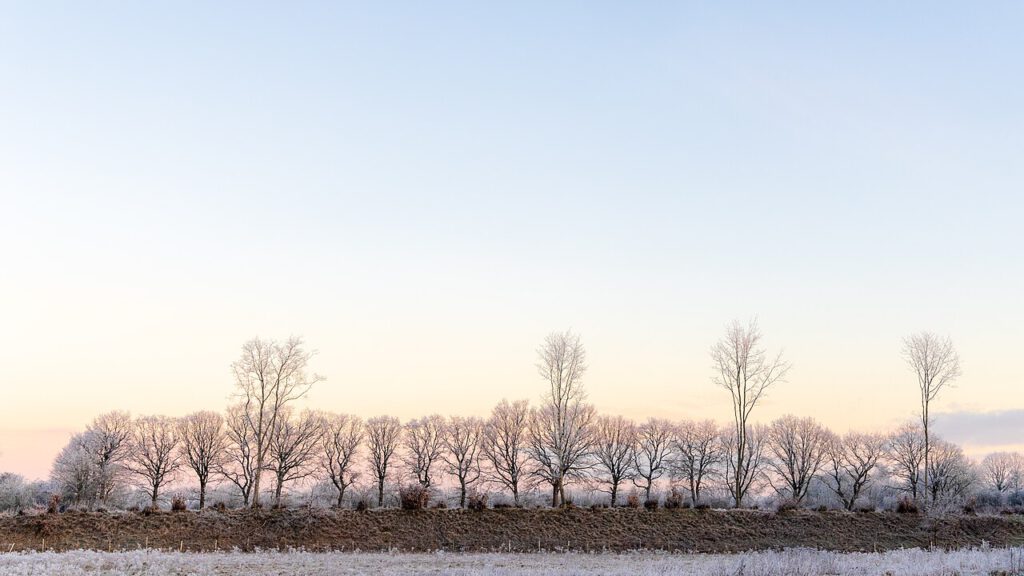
[932,409,1024,450]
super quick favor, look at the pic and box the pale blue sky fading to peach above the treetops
[0,1,1024,478]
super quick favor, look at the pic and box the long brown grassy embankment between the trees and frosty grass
[0,509,1024,553]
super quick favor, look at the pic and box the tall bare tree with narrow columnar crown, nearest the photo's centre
[529,331,595,506]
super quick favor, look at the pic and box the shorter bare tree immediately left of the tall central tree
[482,400,529,506]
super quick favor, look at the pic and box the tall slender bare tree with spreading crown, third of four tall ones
[711,320,790,507]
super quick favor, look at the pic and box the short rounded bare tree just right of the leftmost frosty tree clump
[126,416,181,508]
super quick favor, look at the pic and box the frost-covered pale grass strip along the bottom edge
[0,548,1024,576]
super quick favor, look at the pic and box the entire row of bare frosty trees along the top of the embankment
[0,322,1024,511]
